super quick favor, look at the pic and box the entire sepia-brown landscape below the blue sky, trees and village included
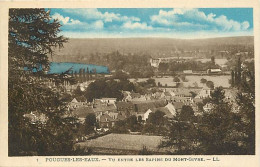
[8,9,255,156]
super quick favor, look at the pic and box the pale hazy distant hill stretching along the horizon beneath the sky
[52,36,254,62]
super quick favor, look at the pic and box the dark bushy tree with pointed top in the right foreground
[198,87,242,155]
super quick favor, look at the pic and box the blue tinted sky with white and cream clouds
[51,8,253,39]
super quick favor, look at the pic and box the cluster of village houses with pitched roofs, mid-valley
[65,88,238,128]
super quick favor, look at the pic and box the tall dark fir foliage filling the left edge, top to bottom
[8,9,81,156]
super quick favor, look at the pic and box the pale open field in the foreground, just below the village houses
[78,134,170,152]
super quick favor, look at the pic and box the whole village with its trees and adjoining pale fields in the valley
[20,47,252,154]
